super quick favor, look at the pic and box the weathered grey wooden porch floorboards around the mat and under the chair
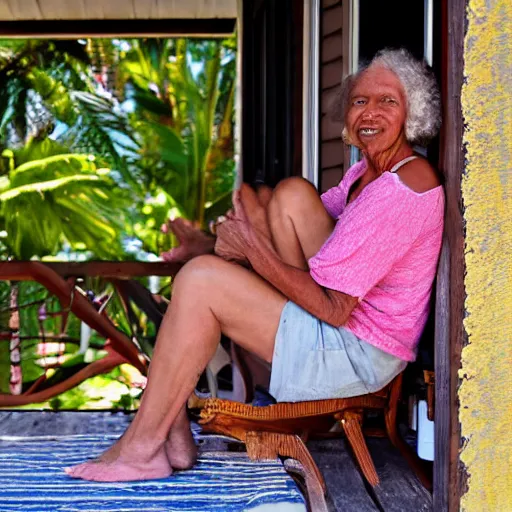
[0,411,432,512]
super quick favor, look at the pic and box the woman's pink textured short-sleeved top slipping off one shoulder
[309,160,444,361]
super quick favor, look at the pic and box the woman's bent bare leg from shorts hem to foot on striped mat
[67,256,286,481]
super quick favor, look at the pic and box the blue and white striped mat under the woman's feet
[0,433,306,512]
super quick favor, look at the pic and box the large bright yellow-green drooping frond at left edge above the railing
[0,147,126,259]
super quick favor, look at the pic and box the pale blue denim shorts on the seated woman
[269,302,407,402]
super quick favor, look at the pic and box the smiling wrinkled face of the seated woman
[345,67,407,156]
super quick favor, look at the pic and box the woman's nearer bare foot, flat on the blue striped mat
[64,440,172,482]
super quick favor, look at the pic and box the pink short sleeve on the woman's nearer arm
[309,176,425,298]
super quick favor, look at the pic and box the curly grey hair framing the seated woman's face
[330,48,441,145]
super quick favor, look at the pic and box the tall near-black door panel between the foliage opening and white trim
[242,0,302,186]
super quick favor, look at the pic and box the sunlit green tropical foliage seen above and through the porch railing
[0,38,236,408]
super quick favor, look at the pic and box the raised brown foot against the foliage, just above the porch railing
[161,218,215,263]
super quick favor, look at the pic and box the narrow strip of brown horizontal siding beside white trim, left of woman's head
[319,0,344,192]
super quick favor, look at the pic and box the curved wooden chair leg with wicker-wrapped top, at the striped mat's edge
[245,432,327,512]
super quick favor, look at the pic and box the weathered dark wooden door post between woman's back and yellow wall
[434,0,467,512]
